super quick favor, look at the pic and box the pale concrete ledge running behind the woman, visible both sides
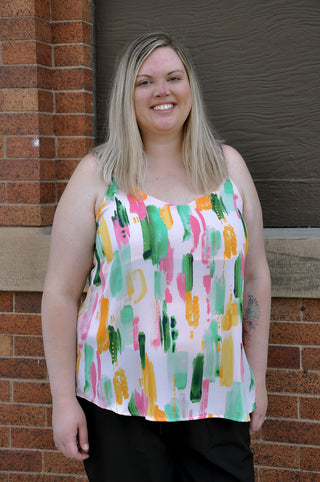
[0,227,320,298]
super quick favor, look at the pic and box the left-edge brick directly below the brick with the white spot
[0,159,40,181]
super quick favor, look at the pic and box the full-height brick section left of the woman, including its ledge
[0,0,93,482]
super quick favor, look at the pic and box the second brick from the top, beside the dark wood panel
[52,21,91,45]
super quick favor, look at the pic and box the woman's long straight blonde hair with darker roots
[94,33,227,193]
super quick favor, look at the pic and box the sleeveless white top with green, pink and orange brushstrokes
[77,180,255,421]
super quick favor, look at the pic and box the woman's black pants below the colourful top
[79,399,254,482]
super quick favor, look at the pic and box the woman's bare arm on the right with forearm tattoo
[224,146,271,434]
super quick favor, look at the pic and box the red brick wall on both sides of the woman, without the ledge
[0,0,320,482]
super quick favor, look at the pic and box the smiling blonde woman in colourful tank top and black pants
[43,34,270,482]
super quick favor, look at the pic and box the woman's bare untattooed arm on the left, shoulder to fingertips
[42,156,99,460]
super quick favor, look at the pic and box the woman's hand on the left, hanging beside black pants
[52,398,89,460]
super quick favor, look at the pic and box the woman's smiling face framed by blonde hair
[134,47,192,142]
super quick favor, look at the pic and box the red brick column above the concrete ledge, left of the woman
[0,0,93,226]
